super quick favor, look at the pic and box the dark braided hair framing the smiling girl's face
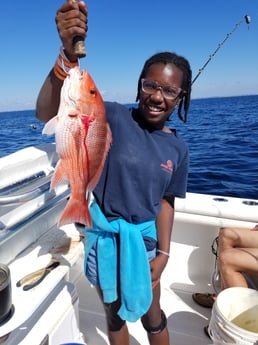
[136,52,192,122]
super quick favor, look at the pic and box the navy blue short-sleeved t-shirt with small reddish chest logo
[94,102,188,224]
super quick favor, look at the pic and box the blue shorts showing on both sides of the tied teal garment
[85,237,157,285]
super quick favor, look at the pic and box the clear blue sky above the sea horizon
[0,0,258,111]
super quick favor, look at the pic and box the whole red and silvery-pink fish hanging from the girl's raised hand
[42,67,112,228]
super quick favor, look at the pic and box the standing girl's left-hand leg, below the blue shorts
[96,287,129,345]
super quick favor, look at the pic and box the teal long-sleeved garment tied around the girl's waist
[85,201,157,322]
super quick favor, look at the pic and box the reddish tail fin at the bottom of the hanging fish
[58,197,92,228]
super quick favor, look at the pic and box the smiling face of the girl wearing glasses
[139,63,183,129]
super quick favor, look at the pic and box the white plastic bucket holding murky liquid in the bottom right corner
[209,287,258,345]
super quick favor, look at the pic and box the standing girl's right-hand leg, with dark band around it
[141,283,169,345]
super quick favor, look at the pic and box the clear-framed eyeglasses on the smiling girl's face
[141,79,183,101]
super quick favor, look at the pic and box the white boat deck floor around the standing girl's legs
[76,264,212,345]
